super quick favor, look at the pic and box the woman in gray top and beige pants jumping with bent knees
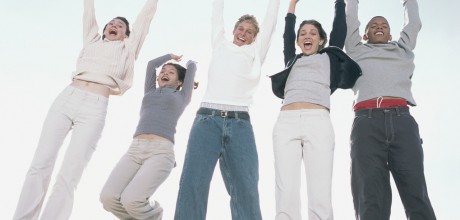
[100,54,196,219]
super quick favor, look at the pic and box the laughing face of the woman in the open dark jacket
[297,24,325,55]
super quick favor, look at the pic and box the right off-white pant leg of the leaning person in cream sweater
[41,89,108,220]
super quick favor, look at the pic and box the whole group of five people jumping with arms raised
[13,0,436,220]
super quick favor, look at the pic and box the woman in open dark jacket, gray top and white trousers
[271,0,360,220]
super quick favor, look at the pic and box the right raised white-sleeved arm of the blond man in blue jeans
[256,0,280,64]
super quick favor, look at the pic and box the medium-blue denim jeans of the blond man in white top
[174,110,262,220]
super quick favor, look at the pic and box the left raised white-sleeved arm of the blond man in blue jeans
[211,0,225,48]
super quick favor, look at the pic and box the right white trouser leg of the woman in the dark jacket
[300,109,335,220]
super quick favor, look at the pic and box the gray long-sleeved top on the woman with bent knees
[134,54,196,143]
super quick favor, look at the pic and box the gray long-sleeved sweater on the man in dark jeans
[345,0,422,106]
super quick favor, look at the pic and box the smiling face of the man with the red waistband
[363,16,391,44]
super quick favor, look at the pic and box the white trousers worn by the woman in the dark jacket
[273,109,335,220]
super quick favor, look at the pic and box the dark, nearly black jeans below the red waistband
[351,108,436,220]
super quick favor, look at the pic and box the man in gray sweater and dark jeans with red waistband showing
[345,0,436,220]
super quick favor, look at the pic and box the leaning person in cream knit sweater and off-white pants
[13,0,158,220]
